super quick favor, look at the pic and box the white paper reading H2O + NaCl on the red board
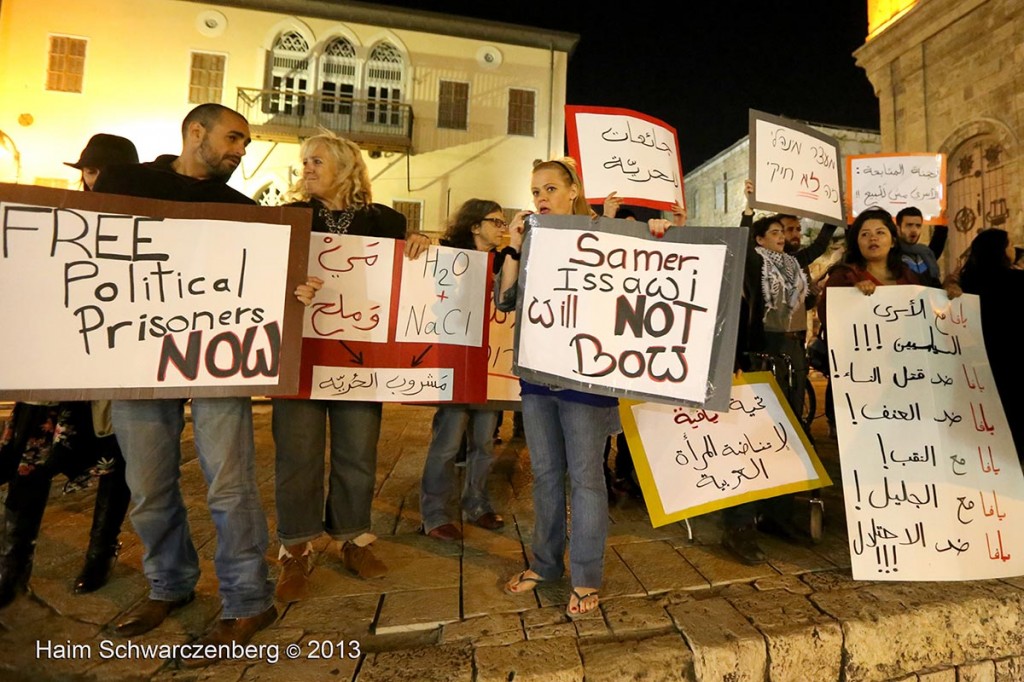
[395,246,490,346]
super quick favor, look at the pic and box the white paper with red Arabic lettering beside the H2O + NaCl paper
[302,232,394,343]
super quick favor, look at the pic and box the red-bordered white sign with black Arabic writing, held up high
[565,106,683,209]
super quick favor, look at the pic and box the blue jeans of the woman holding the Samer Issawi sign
[522,393,620,588]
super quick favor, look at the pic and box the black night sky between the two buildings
[372,0,879,171]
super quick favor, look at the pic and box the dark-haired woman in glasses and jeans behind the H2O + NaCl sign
[420,199,509,542]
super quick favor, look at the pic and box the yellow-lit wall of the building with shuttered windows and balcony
[0,0,567,229]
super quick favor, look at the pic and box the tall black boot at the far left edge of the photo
[0,472,50,608]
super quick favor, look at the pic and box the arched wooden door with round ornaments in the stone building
[946,133,1013,268]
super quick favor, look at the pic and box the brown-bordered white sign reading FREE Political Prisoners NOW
[0,184,310,400]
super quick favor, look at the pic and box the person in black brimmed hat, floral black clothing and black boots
[0,134,138,608]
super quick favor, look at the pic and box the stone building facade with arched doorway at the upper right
[854,0,1024,266]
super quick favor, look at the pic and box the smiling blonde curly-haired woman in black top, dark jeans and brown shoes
[272,133,430,601]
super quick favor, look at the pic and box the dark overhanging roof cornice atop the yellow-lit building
[178,0,580,54]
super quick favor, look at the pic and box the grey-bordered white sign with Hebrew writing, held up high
[750,109,843,224]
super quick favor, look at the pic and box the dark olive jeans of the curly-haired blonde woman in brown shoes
[272,399,381,545]
